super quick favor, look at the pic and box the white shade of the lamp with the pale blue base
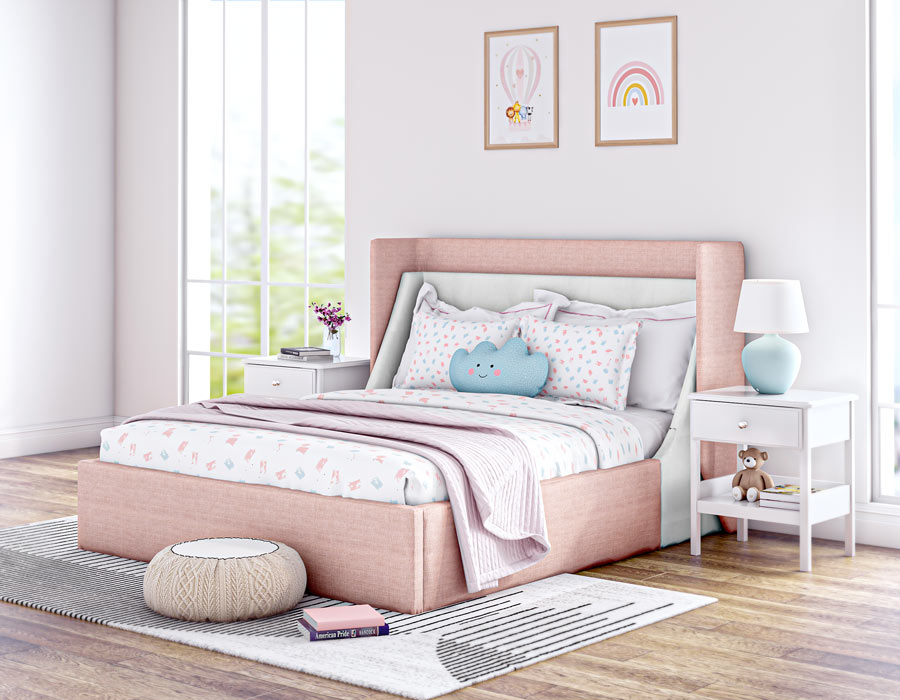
[734,280,809,333]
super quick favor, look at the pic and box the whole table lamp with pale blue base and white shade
[734,280,809,394]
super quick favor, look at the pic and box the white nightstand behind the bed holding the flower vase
[244,356,369,399]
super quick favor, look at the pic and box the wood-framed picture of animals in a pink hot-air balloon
[484,26,559,151]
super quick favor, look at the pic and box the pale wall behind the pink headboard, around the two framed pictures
[347,0,870,532]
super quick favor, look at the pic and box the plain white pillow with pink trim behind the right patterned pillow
[534,289,697,411]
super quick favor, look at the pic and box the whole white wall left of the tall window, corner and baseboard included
[0,0,181,457]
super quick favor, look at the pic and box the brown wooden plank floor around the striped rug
[0,449,900,700]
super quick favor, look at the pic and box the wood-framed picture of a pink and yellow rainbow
[594,16,678,146]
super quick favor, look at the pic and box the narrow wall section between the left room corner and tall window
[115,0,181,416]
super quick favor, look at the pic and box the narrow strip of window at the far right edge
[872,0,900,503]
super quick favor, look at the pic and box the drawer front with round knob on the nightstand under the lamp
[691,401,803,447]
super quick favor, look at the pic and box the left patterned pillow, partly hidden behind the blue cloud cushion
[400,316,519,391]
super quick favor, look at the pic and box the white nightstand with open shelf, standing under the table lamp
[689,386,858,571]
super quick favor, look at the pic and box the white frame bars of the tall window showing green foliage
[179,0,347,403]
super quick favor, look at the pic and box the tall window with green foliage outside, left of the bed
[183,0,344,401]
